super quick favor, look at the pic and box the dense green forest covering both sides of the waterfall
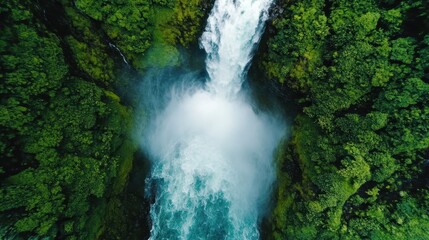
[0,0,429,240]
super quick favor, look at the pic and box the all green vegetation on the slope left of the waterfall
[0,0,204,239]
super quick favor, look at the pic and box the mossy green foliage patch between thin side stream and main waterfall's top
[76,0,210,69]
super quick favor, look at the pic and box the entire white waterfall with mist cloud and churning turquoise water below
[144,0,284,239]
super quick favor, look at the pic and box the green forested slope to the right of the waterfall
[263,0,429,239]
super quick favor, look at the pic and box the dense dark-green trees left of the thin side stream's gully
[0,1,134,239]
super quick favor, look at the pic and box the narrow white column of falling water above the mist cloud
[200,0,271,95]
